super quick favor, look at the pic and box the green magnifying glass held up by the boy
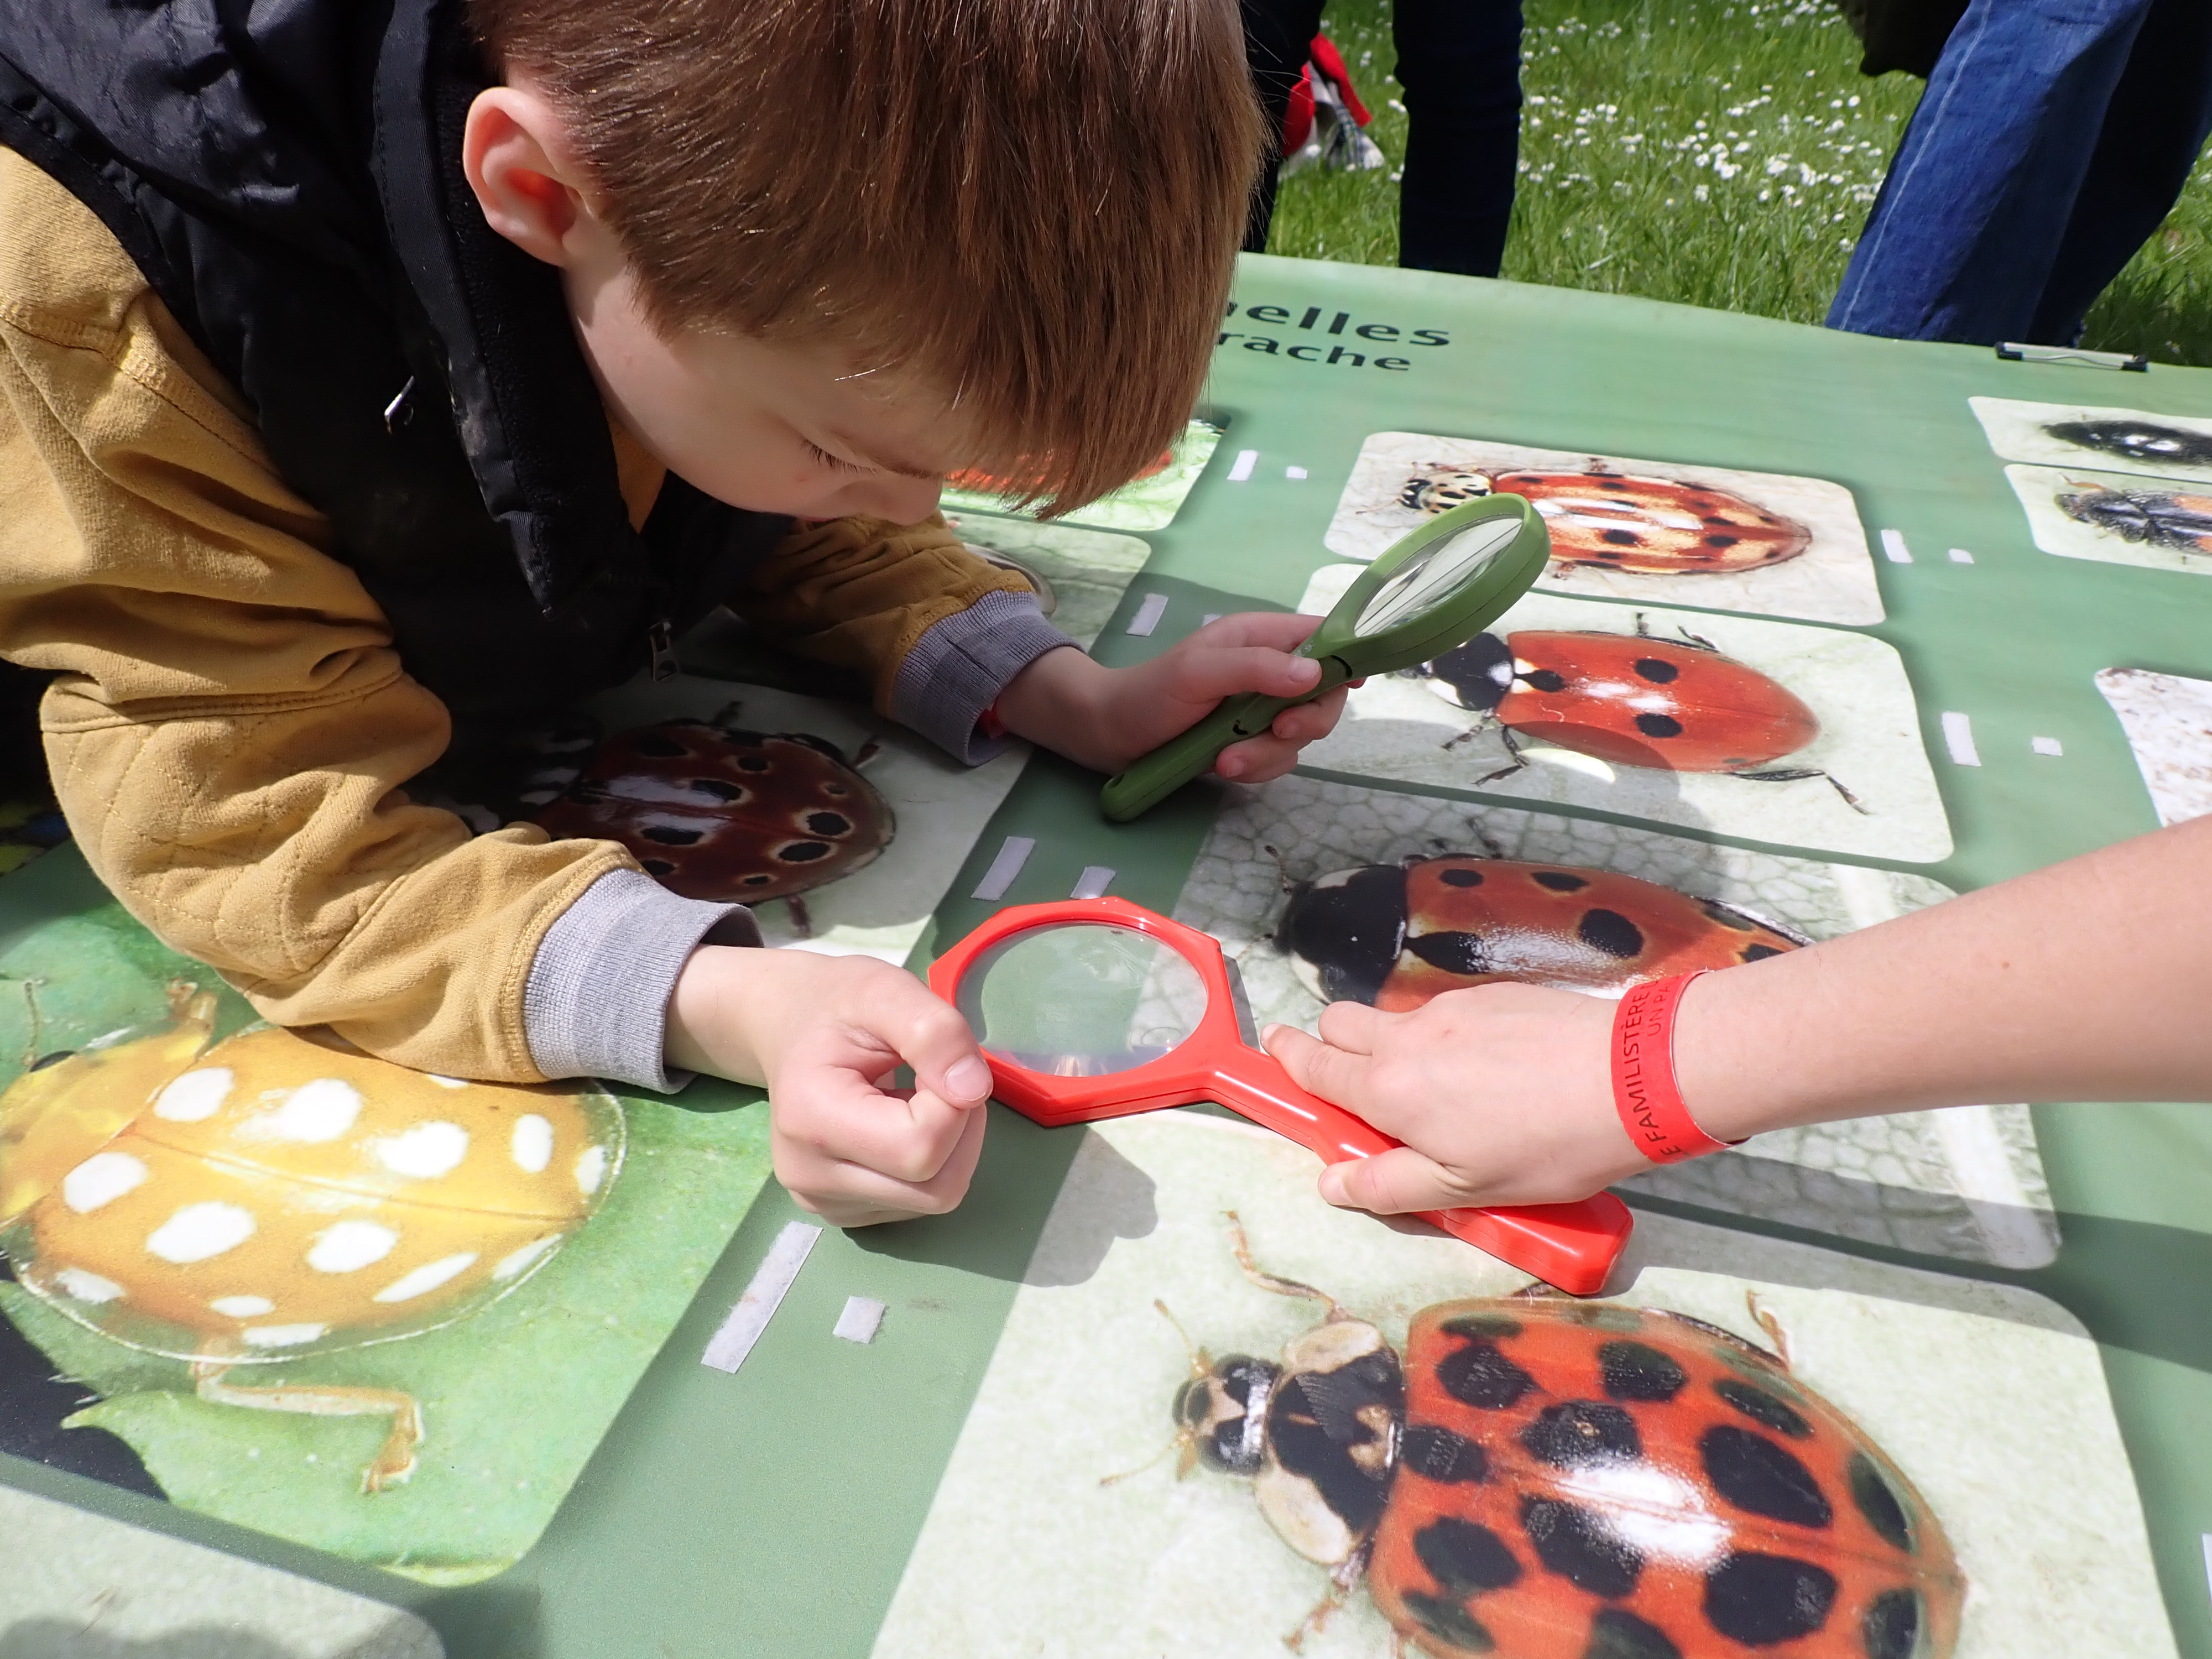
[1099,495,1551,823]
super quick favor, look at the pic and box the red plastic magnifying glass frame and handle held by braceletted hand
[929,898,1635,1296]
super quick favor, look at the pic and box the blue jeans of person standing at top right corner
[1827,0,2212,345]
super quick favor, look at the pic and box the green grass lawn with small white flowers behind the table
[1267,0,2212,365]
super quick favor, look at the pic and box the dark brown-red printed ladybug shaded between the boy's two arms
[538,719,896,905]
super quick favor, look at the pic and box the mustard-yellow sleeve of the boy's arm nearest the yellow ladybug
[0,153,655,1082]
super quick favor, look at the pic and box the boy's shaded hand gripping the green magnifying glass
[998,611,1345,783]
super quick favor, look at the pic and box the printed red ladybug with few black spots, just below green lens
[1413,615,1865,812]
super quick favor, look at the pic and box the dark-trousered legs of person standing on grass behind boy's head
[1243,0,1522,276]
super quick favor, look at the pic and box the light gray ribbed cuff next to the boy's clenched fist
[522,869,761,1088]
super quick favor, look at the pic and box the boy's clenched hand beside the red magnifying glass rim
[668,945,991,1228]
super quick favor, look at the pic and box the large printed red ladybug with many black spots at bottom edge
[1175,1217,1966,1659]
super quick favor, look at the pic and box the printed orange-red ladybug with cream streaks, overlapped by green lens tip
[1398,460,1812,575]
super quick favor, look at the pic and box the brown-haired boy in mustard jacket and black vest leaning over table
[0,0,1336,1225]
